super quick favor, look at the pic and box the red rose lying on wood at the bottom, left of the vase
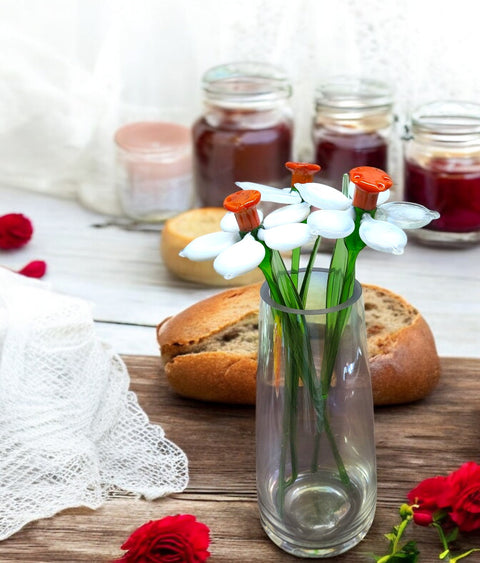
[116,514,210,563]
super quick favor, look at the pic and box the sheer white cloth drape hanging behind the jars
[0,0,480,213]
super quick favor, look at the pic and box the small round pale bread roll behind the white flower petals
[160,207,262,287]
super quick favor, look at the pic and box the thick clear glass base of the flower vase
[260,473,376,558]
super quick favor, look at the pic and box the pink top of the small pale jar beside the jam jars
[115,121,190,156]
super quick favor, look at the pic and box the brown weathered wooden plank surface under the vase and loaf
[0,356,480,563]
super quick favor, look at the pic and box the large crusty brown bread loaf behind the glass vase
[157,283,440,406]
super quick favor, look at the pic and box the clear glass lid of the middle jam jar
[315,76,393,110]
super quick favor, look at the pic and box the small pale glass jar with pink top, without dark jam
[115,121,193,222]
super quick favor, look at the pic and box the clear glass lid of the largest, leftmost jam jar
[202,62,292,104]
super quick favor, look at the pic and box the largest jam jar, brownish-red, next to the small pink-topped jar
[192,62,293,207]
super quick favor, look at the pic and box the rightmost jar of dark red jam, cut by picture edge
[404,101,480,248]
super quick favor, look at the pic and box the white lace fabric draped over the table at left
[0,268,188,540]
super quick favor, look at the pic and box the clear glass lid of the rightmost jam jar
[411,100,480,141]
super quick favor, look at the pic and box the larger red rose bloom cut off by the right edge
[448,461,480,532]
